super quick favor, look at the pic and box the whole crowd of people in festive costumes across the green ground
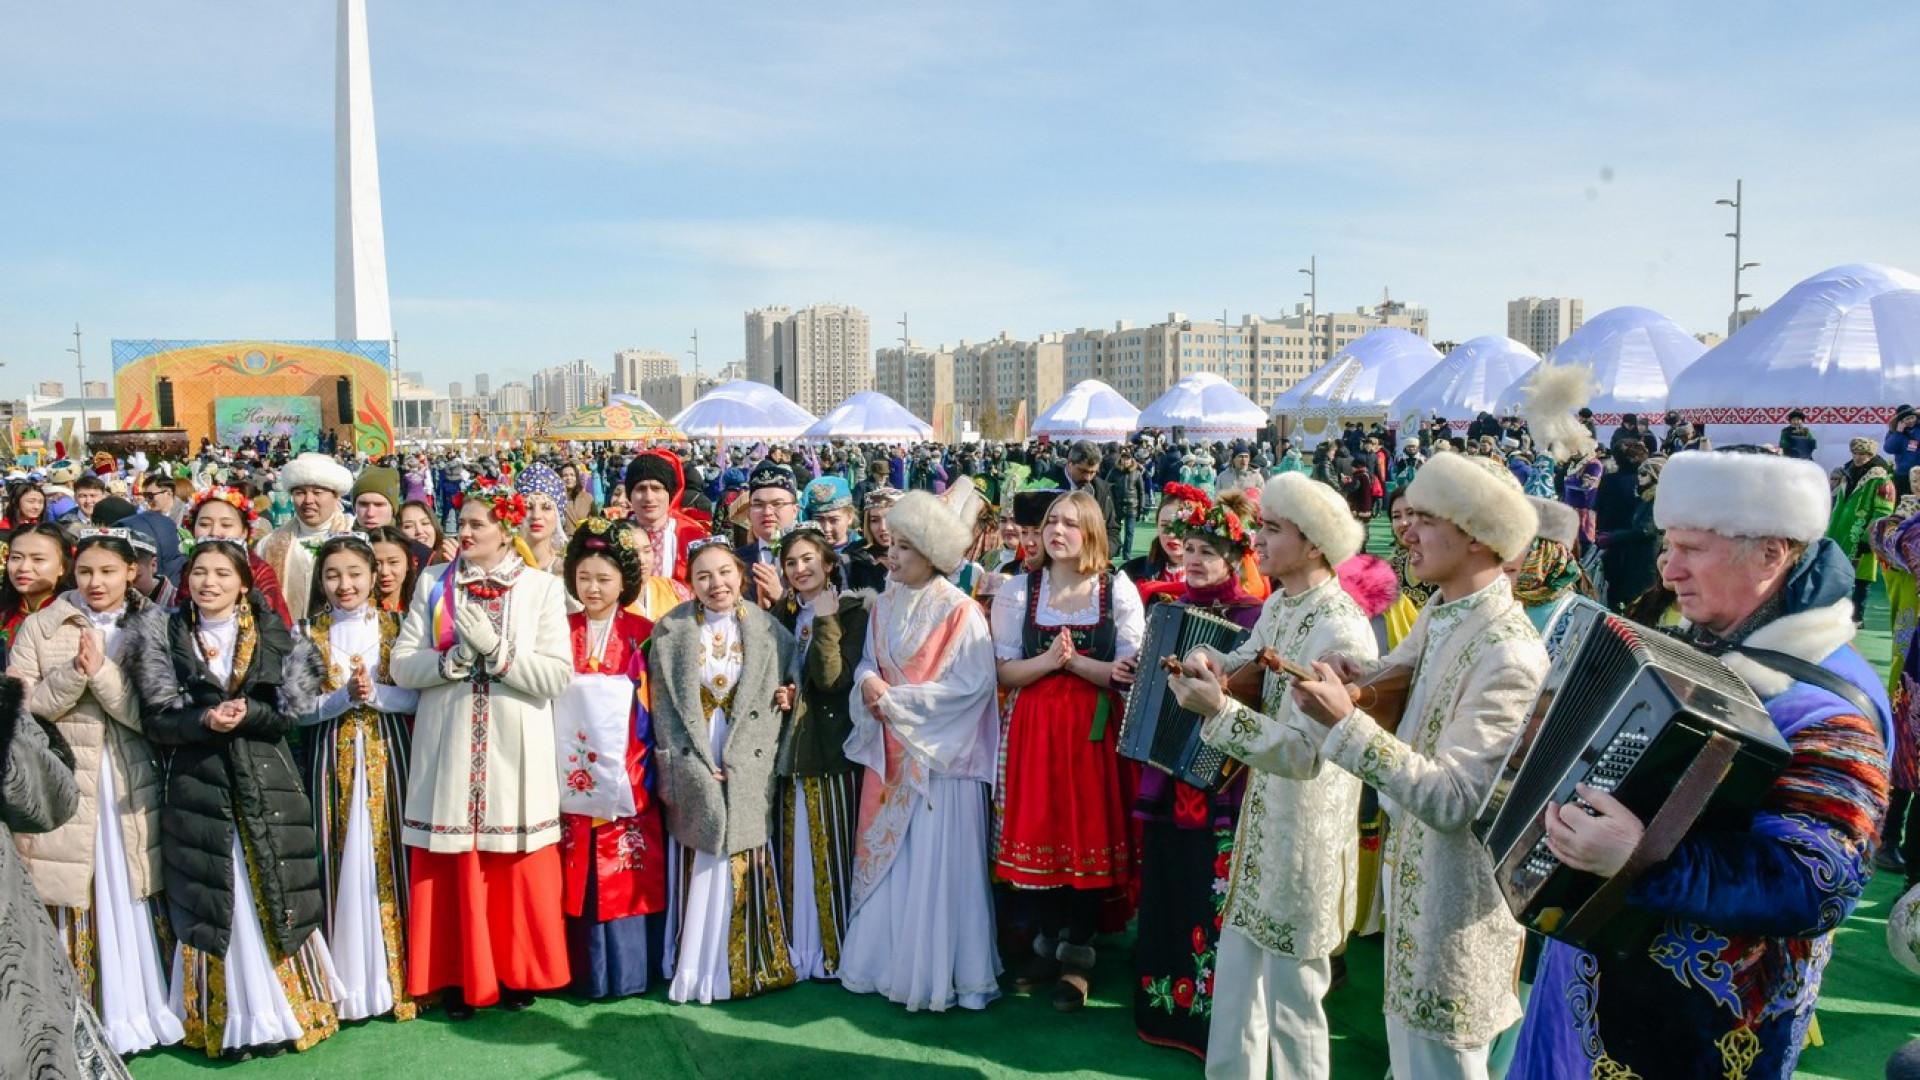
[0,409,1920,1078]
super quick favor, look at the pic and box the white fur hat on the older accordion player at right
[1653,450,1832,544]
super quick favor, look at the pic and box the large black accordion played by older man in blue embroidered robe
[1473,600,1791,951]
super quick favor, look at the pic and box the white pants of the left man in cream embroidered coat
[1206,926,1332,1080]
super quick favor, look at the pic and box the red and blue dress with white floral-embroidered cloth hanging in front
[555,611,666,997]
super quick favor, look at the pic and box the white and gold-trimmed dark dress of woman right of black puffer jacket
[307,605,420,1020]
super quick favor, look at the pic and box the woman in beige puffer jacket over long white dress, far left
[8,528,186,1053]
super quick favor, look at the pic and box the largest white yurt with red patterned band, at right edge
[1667,263,1920,467]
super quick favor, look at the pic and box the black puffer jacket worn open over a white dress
[129,592,324,959]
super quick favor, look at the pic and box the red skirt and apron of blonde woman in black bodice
[995,673,1137,892]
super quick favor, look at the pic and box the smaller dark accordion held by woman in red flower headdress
[1117,603,1248,790]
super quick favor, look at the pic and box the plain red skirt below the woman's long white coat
[407,844,570,1005]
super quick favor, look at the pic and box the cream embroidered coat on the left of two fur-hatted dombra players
[1200,577,1377,961]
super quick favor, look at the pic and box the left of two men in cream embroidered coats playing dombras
[1169,473,1375,1078]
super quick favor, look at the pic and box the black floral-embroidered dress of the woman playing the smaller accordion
[1133,575,1261,1057]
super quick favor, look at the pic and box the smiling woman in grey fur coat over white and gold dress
[649,540,797,1005]
